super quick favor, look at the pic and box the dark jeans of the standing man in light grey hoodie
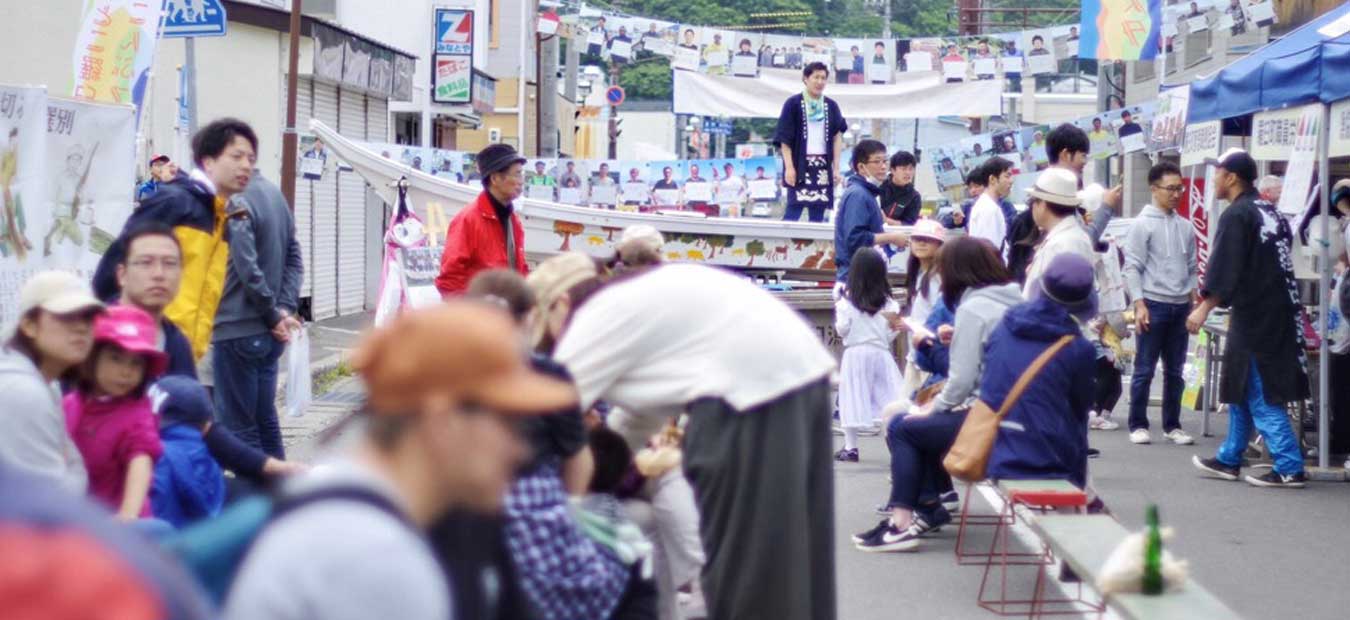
[1130,300,1191,432]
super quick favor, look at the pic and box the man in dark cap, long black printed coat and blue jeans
[1187,149,1308,488]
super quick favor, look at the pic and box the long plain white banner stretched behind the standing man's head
[675,69,1003,120]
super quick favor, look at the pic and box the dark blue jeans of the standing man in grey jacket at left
[213,334,286,459]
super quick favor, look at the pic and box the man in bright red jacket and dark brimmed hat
[436,145,529,296]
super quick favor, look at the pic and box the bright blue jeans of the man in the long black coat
[1216,359,1303,475]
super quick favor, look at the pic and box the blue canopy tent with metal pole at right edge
[1187,3,1350,469]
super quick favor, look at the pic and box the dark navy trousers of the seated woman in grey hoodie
[886,411,967,511]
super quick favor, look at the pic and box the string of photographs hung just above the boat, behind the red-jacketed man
[365,143,784,216]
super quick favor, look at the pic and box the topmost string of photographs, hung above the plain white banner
[563,0,1274,83]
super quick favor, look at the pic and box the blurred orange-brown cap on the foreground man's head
[351,300,578,415]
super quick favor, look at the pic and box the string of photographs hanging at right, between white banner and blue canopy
[923,101,1158,196]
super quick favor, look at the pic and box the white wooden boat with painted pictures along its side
[311,120,903,275]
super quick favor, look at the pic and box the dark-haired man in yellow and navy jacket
[93,119,258,359]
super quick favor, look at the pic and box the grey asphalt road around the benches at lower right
[834,405,1350,620]
